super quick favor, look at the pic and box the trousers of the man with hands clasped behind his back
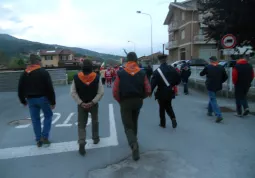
[78,104,99,144]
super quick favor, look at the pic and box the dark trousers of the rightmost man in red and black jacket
[235,87,249,115]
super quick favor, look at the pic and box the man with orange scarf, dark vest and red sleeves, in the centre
[113,52,151,161]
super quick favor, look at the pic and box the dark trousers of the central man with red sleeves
[120,98,143,148]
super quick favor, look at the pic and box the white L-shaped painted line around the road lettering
[0,104,119,159]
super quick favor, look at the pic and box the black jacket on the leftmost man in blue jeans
[18,68,56,105]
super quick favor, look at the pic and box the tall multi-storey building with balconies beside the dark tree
[164,0,218,61]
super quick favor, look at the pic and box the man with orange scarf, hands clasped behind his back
[71,59,104,156]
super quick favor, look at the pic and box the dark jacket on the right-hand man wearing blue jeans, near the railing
[200,64,228,92]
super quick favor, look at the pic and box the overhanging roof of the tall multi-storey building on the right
[164,0,197,25]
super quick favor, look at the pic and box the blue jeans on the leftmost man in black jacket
[28,97,53,141]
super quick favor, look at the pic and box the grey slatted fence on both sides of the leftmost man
[0,68,67,92]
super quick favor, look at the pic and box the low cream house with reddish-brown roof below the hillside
[39,49,75,67]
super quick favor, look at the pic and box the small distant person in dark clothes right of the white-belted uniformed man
[181,61,191,95]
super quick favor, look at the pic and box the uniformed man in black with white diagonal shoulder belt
[151,55,181,128]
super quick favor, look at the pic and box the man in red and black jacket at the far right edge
[232,59,254,117]
